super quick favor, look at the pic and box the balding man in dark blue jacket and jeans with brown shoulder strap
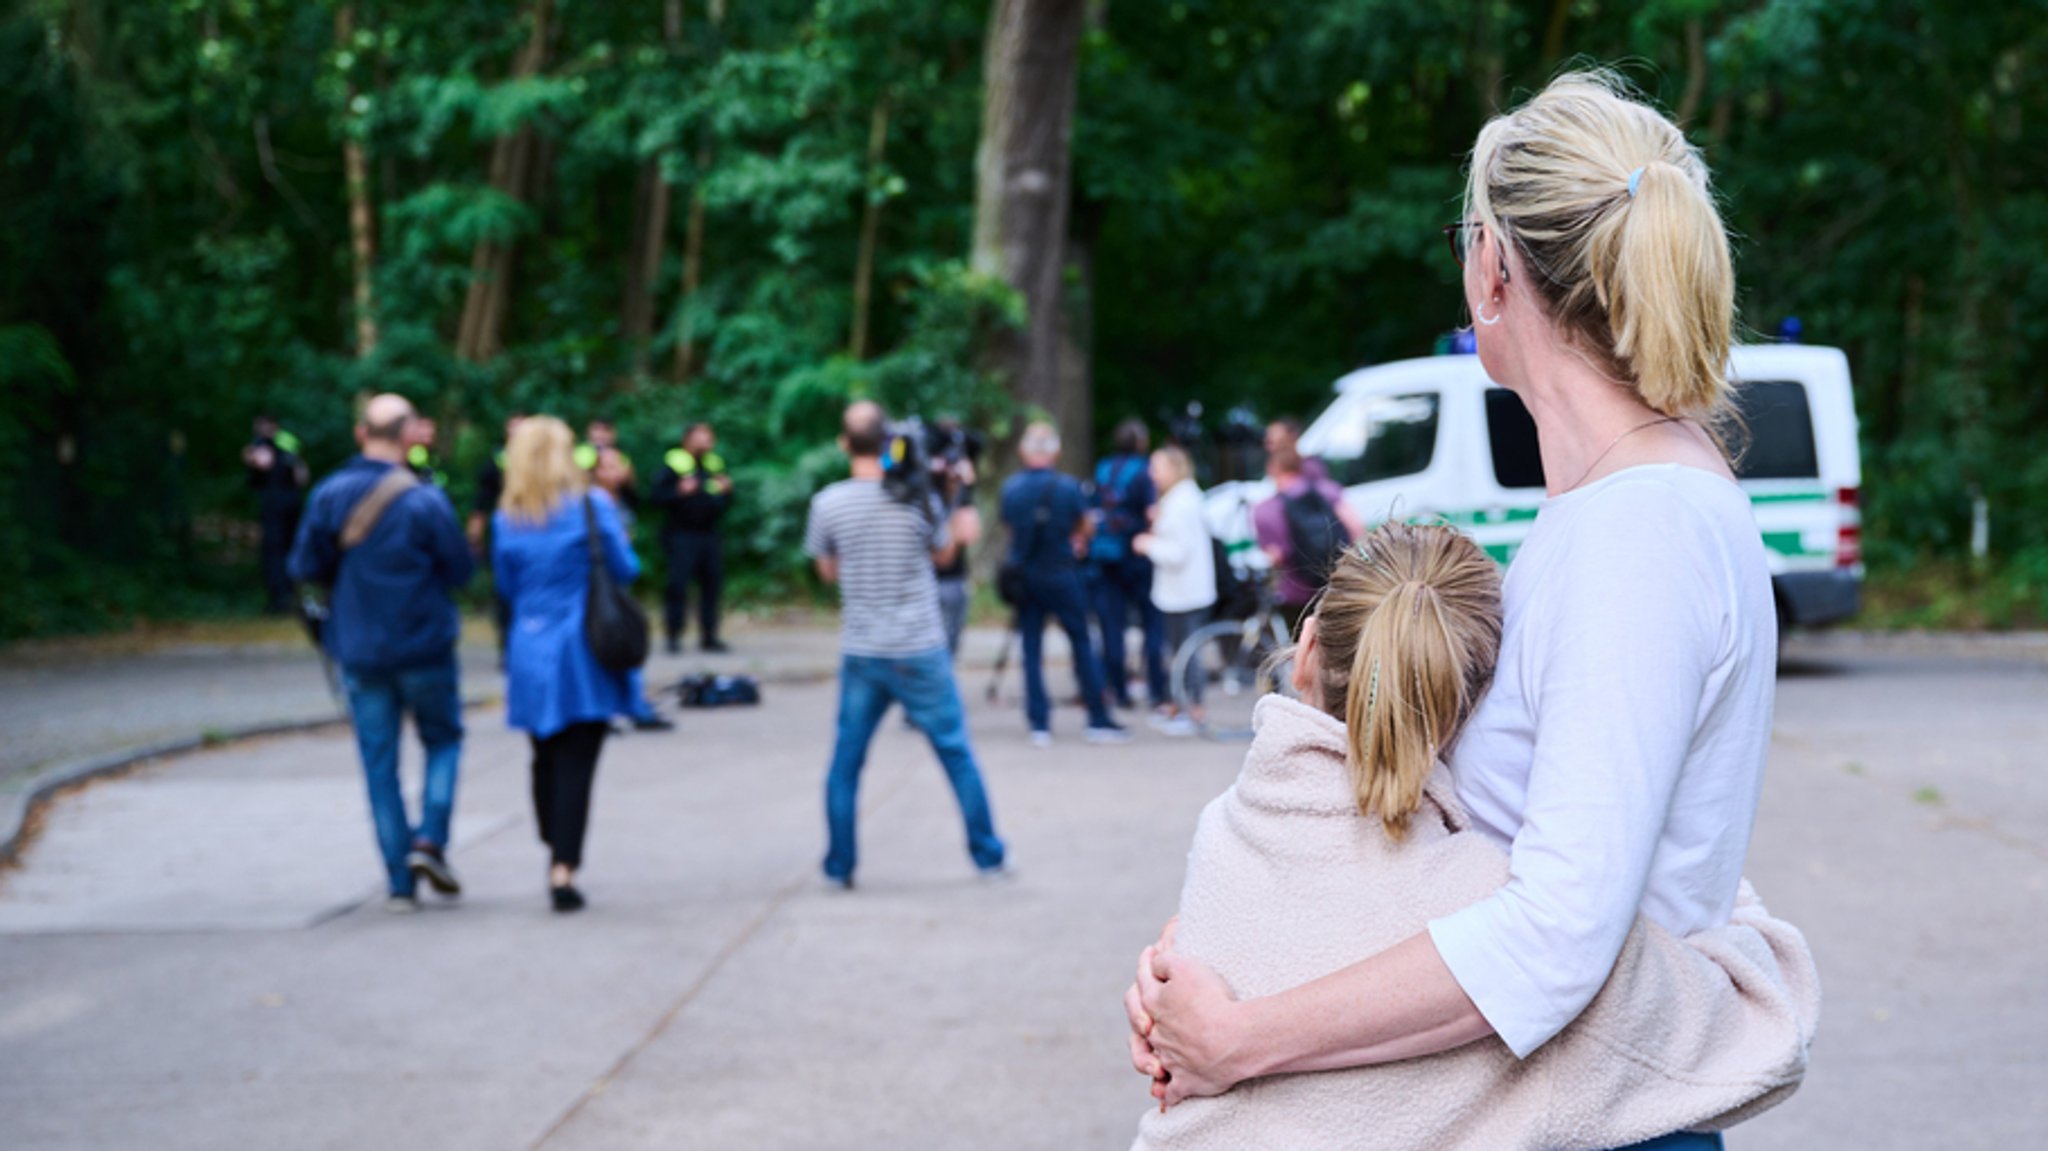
[291,395,475,911]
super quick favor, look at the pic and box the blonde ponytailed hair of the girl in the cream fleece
[1315,522,1501,842]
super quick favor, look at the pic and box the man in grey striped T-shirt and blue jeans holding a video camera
[803,401,1008,889]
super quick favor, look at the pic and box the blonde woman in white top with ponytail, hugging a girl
[1126,74,1806,1149]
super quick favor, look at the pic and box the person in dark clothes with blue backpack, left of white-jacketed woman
[1087,420,1169,711]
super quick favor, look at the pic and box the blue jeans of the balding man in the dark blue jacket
[342,655,463,895]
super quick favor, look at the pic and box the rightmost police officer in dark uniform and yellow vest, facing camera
[651,424,733,655]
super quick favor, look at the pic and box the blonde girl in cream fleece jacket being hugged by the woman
[1137,524,1819,1151]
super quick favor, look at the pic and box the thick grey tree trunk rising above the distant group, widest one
[973,0,1087,456]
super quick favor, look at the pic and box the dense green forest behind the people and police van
[0,0,2048,637]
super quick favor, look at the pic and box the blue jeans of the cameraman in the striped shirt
[825,647,1004,879]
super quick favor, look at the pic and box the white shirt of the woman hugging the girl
[1430,465,1778,1055]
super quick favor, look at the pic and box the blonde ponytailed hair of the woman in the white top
[1464,72,1735,428]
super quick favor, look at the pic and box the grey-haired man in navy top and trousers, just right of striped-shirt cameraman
[1001,424,1130,748]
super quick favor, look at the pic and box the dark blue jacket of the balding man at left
[289,457,477,672]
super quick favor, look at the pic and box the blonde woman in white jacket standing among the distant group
[1130,444,1217,735]
